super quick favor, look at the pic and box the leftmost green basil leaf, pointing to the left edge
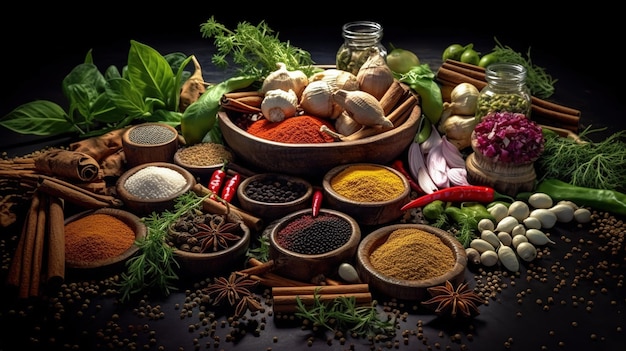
[0,100,74,136]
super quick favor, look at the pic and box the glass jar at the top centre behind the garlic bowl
[336,21,387,75]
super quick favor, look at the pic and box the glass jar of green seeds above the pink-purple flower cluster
[476,63,531,120]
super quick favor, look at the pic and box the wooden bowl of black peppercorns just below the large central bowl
[237,173,313,222]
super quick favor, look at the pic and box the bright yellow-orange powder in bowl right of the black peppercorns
[330,165,405,202]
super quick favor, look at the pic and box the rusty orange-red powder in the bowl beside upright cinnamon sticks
[65,213,135,262]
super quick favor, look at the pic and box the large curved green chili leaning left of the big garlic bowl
[180,76,256,145]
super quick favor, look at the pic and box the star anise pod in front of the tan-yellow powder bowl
[422,281,485,317]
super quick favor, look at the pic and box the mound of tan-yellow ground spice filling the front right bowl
[370,228,455,280]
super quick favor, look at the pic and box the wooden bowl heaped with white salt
[116,162,196,216]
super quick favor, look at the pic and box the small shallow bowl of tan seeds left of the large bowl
[174,143,235,176]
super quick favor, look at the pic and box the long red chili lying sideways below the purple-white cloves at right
[400,185,506,211]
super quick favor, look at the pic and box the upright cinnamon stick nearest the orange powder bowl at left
[47,196,65,287]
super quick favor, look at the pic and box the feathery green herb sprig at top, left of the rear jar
[200,16,316,78]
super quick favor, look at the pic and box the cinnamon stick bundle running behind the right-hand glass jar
[436,59,580,133]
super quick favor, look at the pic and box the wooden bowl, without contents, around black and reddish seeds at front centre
[269,208,361,282]
